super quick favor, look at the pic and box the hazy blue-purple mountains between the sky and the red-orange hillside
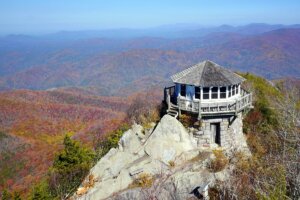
[0,24,300,95]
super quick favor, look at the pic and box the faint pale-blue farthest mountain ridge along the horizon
[17,23,300,40]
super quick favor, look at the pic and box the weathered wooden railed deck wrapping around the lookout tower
[165,86,252,118]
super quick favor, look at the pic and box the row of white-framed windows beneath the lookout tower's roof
[180,85,239,99]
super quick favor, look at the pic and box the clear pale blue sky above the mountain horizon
[0,0,300,34]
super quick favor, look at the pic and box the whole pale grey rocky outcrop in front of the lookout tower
[73,115,251,200]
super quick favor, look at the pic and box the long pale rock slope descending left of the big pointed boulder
[75,124,145,200]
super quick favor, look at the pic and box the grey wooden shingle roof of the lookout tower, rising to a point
[171,60,245,87]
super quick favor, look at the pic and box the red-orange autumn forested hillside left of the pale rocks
[0,90,130,193]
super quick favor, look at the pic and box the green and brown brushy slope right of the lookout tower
[210,74,300,199]
